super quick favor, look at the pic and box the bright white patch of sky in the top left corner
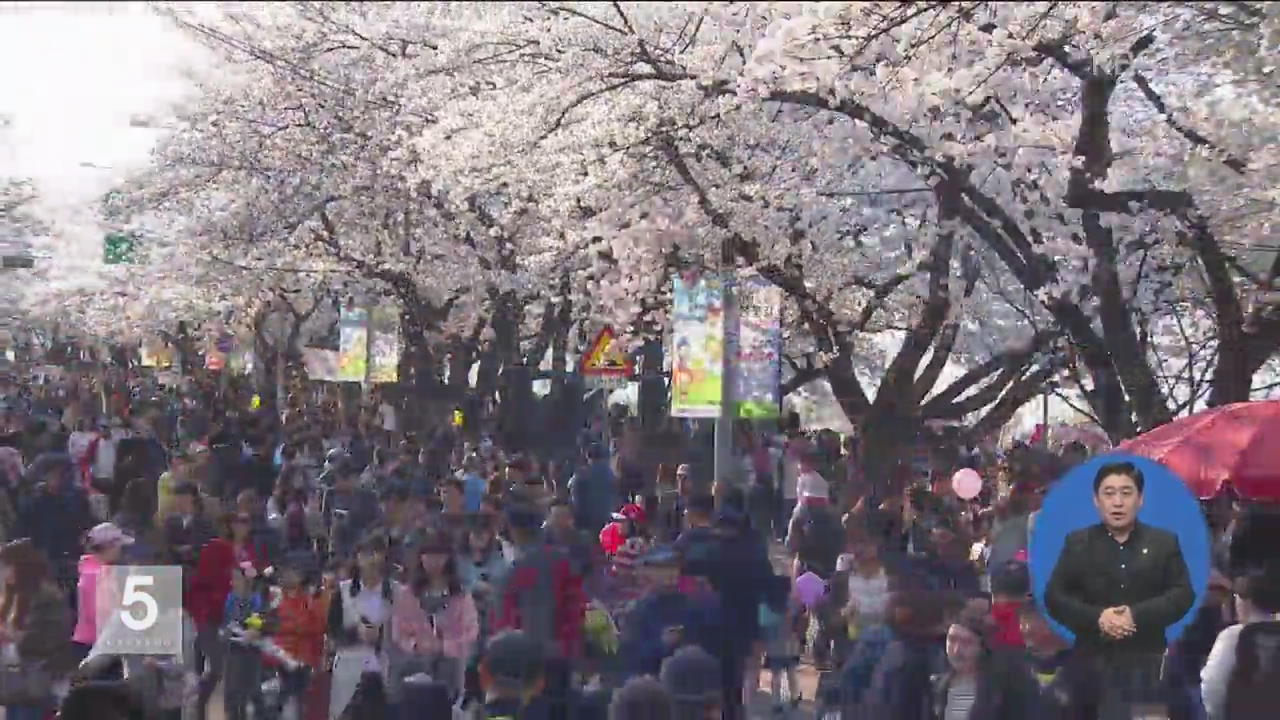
[0,3,201,283]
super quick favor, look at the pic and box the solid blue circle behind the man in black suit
[1027,454,1210,642]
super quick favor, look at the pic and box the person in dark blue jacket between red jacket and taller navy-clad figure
[618,547,723,680]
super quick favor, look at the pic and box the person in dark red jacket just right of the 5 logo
[186,512,265,719]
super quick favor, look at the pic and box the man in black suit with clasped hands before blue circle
[1044,462,1196,717]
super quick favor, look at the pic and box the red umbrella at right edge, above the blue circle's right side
[1116,400,1280,500]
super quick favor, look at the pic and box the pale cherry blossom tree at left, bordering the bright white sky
[107,3,586,440]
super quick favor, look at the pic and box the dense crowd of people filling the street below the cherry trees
[0,376,1280,720]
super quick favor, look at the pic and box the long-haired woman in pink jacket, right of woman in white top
[388,533,480,702]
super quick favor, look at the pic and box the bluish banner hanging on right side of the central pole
[737,275,782,419]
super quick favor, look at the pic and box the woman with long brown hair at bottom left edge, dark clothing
[0,539,76,720]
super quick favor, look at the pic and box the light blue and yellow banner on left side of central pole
[671,274,724,418]
